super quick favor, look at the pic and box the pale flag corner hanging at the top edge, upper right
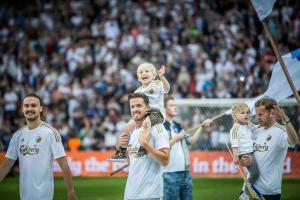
[250,0,276,21]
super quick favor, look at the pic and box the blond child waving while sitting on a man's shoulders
[108,62,170,162]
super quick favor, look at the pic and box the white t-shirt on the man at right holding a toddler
[253,123,290,195]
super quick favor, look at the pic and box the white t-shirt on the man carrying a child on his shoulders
[124,124,170,200]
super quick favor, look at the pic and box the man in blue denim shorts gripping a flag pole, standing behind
[163,97,212,200]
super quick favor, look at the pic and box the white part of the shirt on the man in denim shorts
[164,124,186,172]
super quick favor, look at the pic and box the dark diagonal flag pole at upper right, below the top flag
[262,20,300,105]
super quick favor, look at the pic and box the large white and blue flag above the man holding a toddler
[225,48,300,114]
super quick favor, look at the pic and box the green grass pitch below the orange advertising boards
[0,177,300,200]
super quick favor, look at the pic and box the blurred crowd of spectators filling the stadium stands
[0,0,300,150]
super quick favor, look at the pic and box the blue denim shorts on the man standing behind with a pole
[163,171,193,200]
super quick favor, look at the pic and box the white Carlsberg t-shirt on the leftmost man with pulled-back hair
[6,122,66,200]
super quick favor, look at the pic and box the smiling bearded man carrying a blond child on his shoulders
[117,93,170,200]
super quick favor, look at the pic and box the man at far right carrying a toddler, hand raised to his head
[240,98,299,200]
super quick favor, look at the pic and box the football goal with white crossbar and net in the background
[176,98,299,150]
